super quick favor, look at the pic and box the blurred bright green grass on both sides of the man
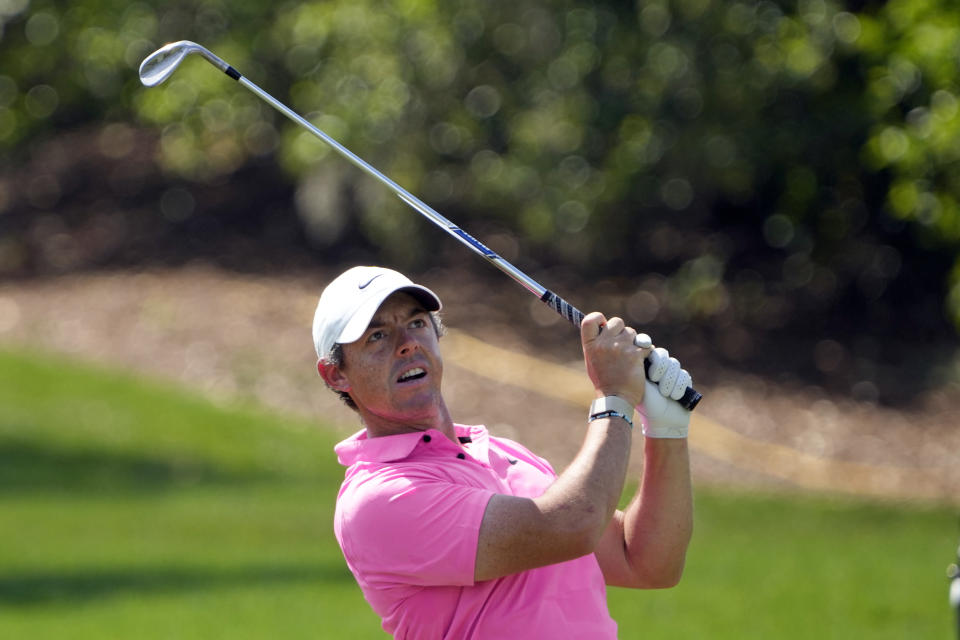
[0,350,957,639]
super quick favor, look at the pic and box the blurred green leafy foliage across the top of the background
[0,0,960,390]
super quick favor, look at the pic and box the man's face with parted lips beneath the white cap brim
[334,292,446,435]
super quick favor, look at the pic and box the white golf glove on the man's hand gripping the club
[637,347,693,438]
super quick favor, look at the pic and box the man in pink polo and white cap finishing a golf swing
[313,267,692,640]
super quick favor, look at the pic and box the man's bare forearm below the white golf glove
[623,438,693,587]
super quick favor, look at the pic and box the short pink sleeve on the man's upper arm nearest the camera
[335,468,495,586]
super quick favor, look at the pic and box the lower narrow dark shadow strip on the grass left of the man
[0,563,353,606]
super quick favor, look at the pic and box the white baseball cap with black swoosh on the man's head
[313,267,442,359]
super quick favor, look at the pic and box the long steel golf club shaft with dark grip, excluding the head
[226,65,702,411]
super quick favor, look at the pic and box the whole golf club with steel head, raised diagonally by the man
[140,40,702,411]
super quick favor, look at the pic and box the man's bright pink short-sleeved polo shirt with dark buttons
[334,425,617,640]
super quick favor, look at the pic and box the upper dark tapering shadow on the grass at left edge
[0,440,274,494]
